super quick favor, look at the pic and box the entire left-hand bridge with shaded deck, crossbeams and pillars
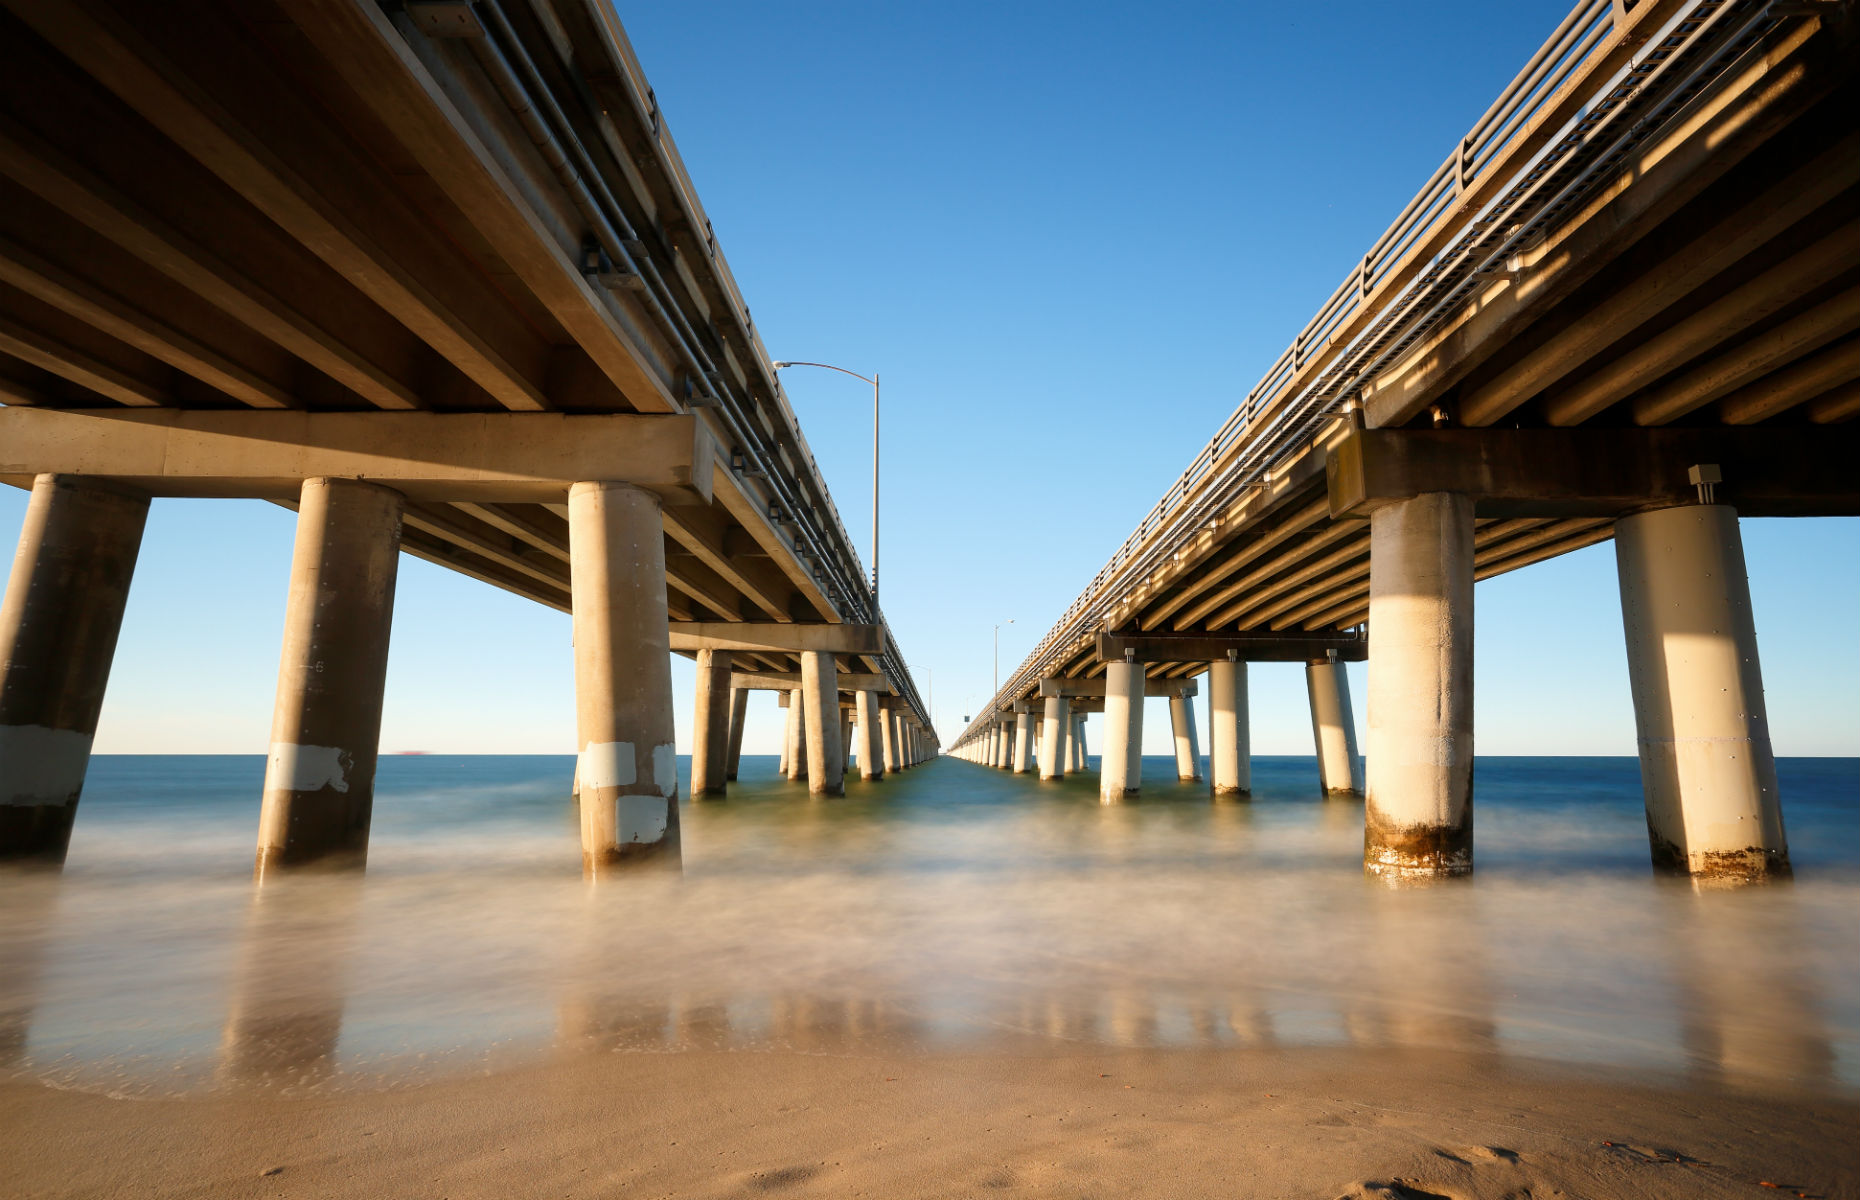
[0,0,937,880]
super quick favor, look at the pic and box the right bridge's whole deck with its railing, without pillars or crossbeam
[965,0,1860,737]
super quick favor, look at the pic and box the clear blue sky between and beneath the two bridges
[0,0,1860,755]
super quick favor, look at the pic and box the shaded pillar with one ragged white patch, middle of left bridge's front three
[253,478,403,884]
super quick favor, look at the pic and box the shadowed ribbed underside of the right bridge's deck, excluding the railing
[1023,28,1860,690]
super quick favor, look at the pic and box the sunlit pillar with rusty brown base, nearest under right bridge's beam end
[1363,491,1473,876]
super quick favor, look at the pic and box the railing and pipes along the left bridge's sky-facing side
[457,0,936,740]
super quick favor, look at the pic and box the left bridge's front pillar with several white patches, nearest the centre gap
[569,482,679,878]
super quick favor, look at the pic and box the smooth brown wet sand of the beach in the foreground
[0,1044,1860,1200]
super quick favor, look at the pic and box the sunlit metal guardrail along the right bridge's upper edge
[956,0,1800,742]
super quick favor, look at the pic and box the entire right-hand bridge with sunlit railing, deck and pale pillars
[952,0,1860,880]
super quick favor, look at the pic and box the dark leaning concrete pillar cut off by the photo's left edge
[0,474,149,867]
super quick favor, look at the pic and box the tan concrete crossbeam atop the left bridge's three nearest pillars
[0,406,716,504]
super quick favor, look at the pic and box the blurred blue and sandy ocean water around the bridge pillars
[0,755,1860,1094]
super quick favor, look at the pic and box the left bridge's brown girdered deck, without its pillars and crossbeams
[0,0,928,710]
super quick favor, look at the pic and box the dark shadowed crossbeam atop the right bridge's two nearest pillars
[1326,426,1860,517]
